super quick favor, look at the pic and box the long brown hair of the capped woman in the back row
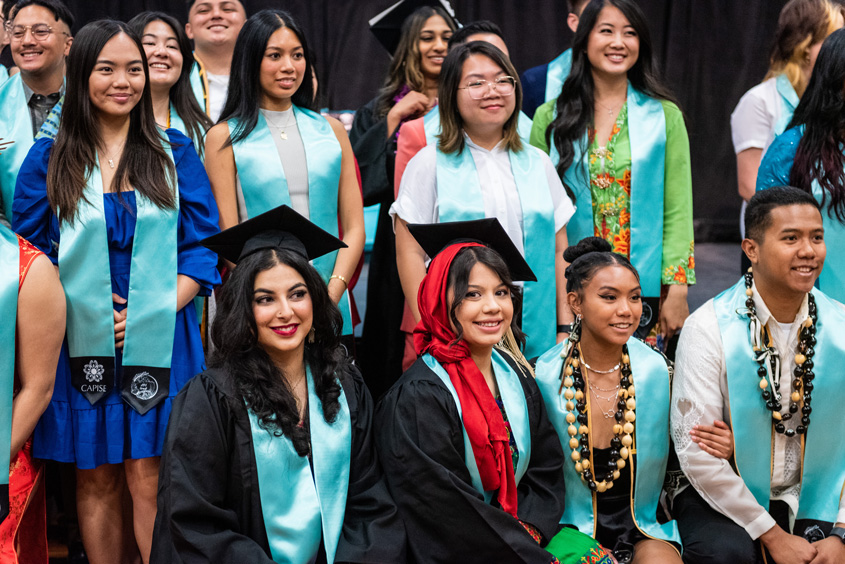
[376,6,456,117]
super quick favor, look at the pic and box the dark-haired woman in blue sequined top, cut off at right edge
[757,29,845,301]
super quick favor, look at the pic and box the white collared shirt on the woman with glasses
[390,134,575,255]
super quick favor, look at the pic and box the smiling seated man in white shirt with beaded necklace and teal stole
[672,187,845,564]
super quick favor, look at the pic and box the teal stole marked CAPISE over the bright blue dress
[59,144,179,415]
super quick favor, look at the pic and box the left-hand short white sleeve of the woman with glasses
[390,144,439,229]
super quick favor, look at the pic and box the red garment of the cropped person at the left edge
[0,237,49,564]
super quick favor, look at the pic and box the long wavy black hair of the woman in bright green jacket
[546,0,677,201]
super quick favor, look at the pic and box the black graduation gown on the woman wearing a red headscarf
[375,359,564,564]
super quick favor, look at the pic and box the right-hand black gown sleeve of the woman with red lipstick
[335,368,405,564]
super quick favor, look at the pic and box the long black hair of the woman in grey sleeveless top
[218,10,315,143]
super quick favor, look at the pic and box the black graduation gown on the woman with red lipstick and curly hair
[151,370,405,564]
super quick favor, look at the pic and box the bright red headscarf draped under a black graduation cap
[414,243,517,517]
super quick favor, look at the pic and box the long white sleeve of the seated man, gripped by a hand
[672,300,775,539]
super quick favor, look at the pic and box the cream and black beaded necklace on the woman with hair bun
[559,331,637,493]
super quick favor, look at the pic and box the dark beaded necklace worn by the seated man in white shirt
[744,269,818,437]
